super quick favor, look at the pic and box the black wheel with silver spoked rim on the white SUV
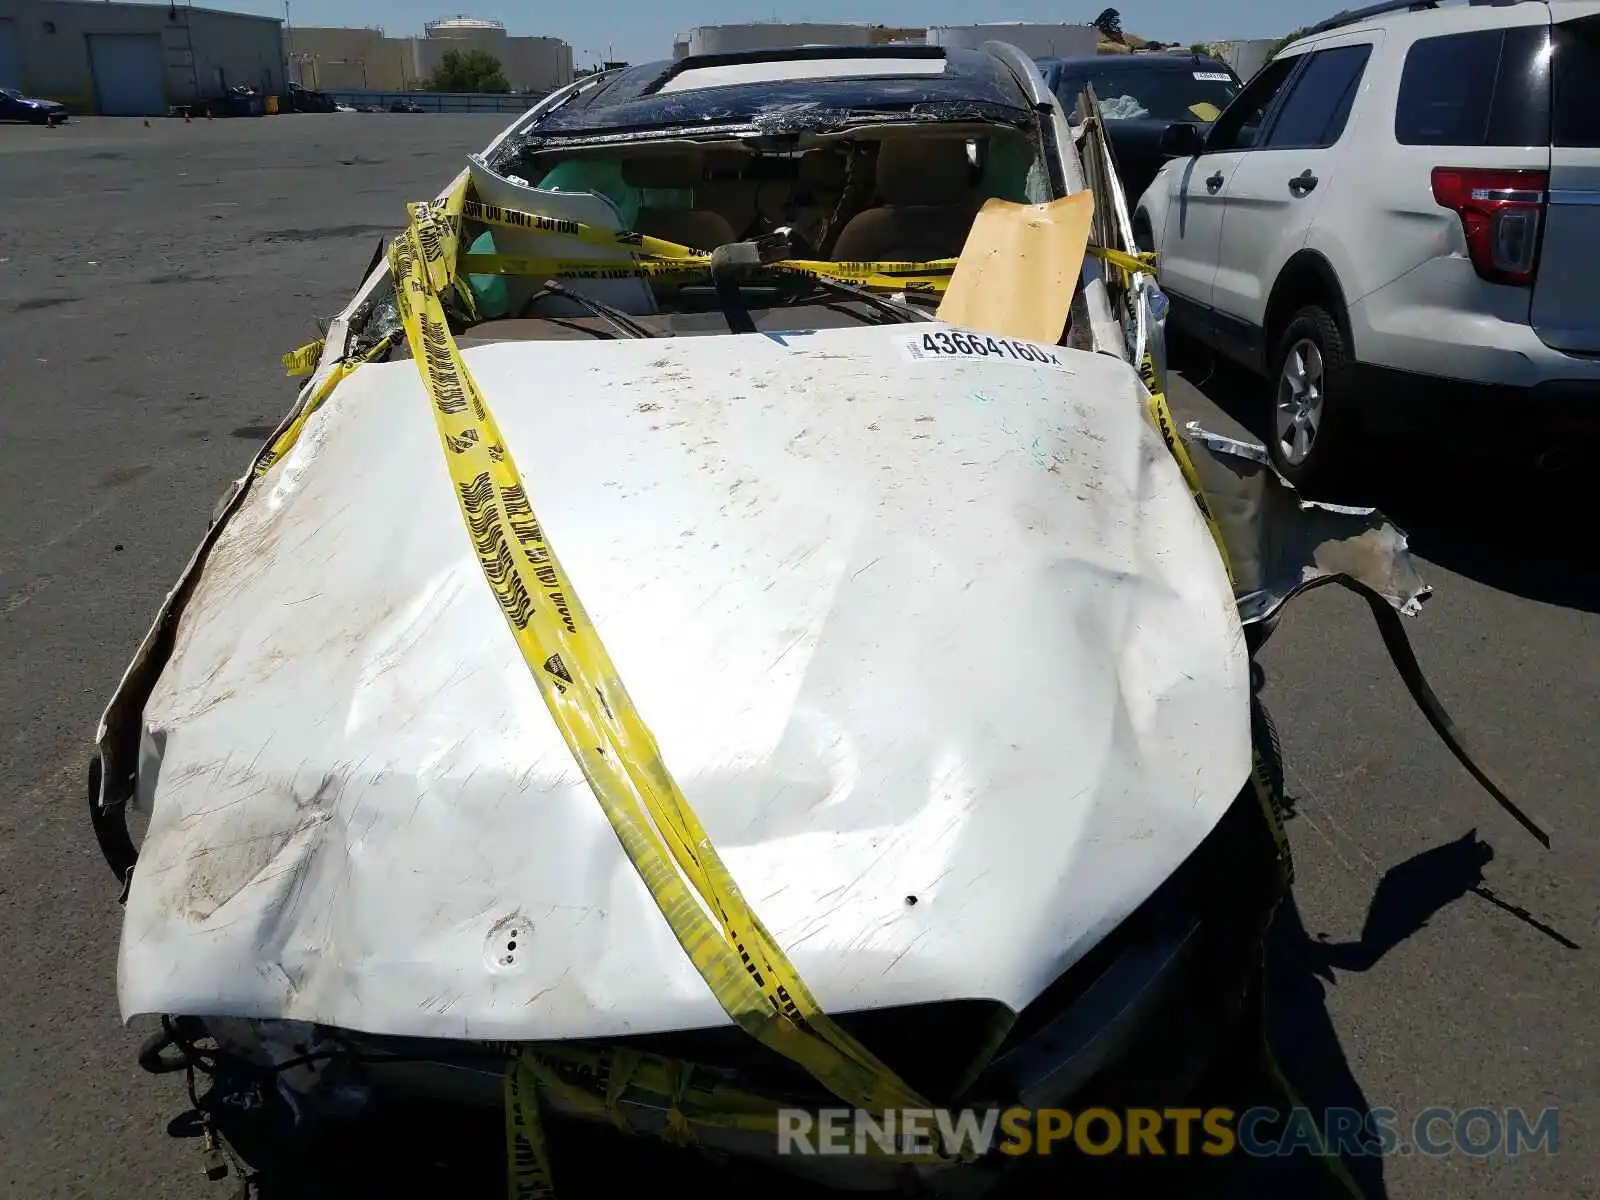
[1267,304,1349,491]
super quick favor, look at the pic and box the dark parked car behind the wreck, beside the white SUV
[1038,54,1243,208]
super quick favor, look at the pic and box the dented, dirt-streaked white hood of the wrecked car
[118,325,1250,1040]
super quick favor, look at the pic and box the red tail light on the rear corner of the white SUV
[1434,166,1549,286]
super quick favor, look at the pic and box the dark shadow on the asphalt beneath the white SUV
[1176,347,1600,613]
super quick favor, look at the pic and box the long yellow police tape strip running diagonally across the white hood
[389,179,928,1196]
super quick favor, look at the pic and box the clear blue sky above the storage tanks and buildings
[219,0,1331,66]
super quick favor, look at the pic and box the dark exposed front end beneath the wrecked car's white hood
[141,786,1282,1195]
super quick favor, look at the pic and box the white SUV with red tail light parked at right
[1134,0,1600,486]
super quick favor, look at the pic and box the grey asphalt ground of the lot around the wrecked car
[0,114,1600,1200]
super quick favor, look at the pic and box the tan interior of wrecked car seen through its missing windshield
[444,125,1046,336]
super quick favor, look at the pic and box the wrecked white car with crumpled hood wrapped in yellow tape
[91,45,1536,1195]
